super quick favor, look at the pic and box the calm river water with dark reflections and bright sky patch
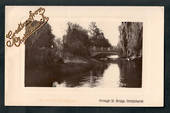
[26,57,142,88]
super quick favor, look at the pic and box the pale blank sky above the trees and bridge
[49,18,120,45]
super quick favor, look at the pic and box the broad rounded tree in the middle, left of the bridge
[63,22,89,57]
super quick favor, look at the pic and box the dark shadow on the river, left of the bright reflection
[25,64,107,87]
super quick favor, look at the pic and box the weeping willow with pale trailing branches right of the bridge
[118,22,143,58]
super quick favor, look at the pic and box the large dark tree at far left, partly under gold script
[25,21,55,67]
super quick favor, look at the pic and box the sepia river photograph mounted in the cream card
[25,11,144,88]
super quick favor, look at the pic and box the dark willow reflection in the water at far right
[118,59,142,88]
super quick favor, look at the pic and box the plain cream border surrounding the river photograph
[5,6,164,107]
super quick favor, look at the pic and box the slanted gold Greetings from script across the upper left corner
[6,7,49,47]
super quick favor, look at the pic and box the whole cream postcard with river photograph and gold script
[4,6,164,107]
